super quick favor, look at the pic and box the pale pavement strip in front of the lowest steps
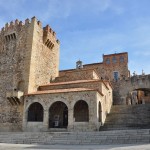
[0,143,150,150]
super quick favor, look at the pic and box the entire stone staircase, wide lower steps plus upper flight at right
[0,104,150,145]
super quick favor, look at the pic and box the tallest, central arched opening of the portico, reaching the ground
[49,101,68,128]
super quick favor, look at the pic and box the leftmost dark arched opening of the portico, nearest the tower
[27,102,43,122]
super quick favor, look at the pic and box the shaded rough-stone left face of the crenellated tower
[0,20,31,131]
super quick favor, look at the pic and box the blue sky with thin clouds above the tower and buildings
[0,0,150,74]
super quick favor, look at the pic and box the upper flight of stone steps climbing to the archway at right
[100,104,150,131]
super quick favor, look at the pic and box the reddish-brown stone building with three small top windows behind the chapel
[83,53,129,81]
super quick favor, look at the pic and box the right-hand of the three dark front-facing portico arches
[74,100,89,122]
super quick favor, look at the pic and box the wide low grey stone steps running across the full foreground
[0,129,150,145]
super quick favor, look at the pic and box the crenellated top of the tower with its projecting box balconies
[0,17,59,46]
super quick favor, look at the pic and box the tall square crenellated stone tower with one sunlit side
[0,17,59,131]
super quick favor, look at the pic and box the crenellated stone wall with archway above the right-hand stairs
[112,75,150,105]
